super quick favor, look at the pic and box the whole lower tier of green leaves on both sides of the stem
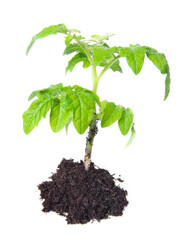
[23,83,133,144]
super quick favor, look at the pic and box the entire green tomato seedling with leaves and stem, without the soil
[23,24,171,170]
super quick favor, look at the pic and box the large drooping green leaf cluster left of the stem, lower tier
[23,83,100,134]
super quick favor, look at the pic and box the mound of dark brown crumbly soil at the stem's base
[38,159,128,224]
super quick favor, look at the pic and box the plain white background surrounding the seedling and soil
[0,0,189,240]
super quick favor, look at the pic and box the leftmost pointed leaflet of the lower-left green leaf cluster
[22,98,52,134]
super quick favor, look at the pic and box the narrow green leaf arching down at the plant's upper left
[26,24,68,55]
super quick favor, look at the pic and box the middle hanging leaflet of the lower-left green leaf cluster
[50,96,72,133]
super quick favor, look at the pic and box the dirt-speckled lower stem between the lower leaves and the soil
[84,115,98,171]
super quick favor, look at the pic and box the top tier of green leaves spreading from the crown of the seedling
[27,24,171,100]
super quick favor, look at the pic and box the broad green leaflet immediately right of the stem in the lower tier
[101,102,123,128]
